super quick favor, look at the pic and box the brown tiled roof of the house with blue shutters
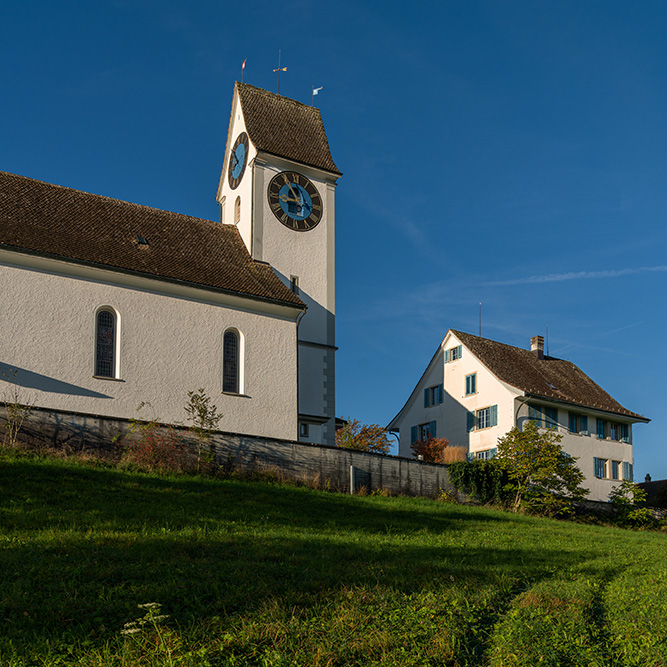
[452,329,649,421]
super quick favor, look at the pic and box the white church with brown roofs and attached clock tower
[0,83,341,445]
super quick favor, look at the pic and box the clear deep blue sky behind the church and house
[0,0,667,479]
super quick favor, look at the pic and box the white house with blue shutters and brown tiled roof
[388,329,649,500]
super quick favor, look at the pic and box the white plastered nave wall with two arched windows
[0,253,298,439]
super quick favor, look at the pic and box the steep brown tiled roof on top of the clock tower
[236,82,341,176]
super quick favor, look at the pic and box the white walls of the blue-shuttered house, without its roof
[389,331,638,500]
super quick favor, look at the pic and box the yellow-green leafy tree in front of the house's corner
[496,421,588,514]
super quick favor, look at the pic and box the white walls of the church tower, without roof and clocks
[217,87,338,445]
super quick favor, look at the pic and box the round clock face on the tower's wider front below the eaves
[267,171,322,232]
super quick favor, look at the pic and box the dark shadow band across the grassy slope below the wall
[0,462,600,643]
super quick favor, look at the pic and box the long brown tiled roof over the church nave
[0,172,304,308]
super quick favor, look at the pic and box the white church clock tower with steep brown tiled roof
[217,83,341,445]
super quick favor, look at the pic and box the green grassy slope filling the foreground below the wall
[0,452,667,667]
